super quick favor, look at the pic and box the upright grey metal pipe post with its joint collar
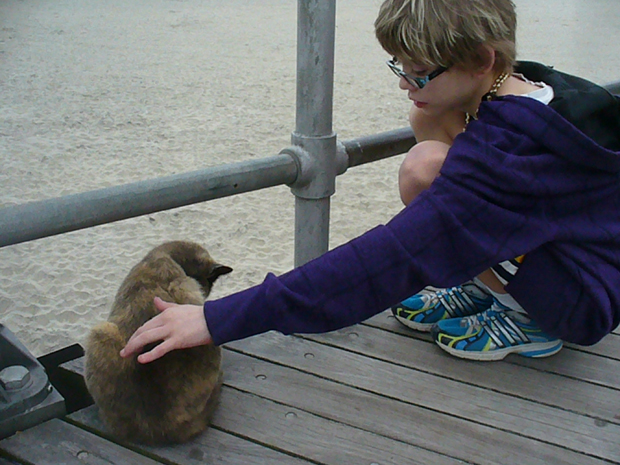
[291,0,337,266]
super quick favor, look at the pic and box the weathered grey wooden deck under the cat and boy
[0,312,620,465]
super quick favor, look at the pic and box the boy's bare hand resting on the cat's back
[121,297,213,363]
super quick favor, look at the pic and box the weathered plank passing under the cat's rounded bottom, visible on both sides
[69,406,309,465]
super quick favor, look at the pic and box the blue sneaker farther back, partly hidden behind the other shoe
[392,281,493,331]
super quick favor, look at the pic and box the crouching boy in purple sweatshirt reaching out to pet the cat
[121,0,620,363]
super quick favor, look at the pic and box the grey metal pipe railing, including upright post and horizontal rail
[0,0,620,266]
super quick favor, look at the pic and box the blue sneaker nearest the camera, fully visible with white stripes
[431,300,562,361]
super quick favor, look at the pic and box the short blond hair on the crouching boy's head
[375,0,517,71]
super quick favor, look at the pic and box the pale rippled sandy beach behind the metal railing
[0,0,620,356]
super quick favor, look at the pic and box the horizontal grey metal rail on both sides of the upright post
[0,128,415,247]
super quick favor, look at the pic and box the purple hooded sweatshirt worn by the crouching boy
[204,66,620,345]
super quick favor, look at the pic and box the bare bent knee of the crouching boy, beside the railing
[398,140,450,205]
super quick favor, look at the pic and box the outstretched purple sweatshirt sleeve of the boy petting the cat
[204,97,620,344]
